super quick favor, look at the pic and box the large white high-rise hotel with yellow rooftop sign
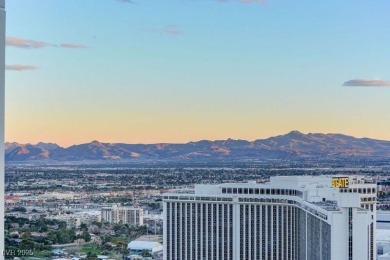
[163,176,376,260]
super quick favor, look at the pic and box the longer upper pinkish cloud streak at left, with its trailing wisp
[5,37,87,49]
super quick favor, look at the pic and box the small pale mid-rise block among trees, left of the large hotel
[101,205,144,226]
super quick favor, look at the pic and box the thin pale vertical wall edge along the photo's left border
[0,0,5,252]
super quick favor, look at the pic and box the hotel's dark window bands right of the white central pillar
[239,205,331,260]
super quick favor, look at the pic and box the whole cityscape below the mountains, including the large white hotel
[4,162,390,260]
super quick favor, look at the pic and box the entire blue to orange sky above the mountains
[5,0,390,146]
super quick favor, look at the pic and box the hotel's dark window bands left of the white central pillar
[164,203,233,260]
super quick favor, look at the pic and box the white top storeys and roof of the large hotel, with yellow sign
[164,176,376,214]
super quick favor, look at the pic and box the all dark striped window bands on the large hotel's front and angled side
[164,202,330,260]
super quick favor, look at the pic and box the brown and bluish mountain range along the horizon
[5,131,390,161]
